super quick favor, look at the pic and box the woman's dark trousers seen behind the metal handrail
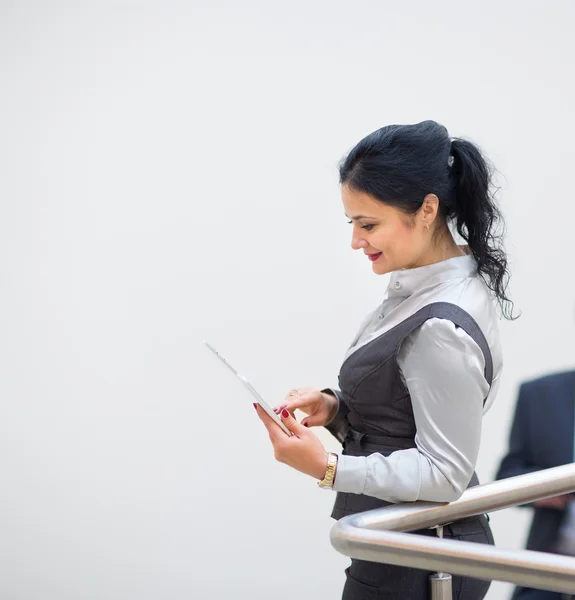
[342,515,493,600]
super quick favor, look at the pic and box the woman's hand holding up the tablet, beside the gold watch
[254,404,327,481]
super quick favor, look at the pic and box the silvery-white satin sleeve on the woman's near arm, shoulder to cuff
[334,319,489,502]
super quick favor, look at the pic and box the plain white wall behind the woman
[0,0,575,600]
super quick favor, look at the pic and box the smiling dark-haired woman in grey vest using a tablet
[256,121,512,600]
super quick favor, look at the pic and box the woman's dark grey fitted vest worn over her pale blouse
[328,302,493,519]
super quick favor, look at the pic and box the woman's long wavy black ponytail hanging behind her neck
[451,138,515,319]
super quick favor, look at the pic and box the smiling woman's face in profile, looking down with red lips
[341,184,433,275]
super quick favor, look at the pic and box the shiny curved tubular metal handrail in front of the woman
[331,463,575,594]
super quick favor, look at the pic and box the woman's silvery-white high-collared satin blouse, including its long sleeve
[333,255,502,502]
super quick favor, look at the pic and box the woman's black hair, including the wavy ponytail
[339,121,513,319]
